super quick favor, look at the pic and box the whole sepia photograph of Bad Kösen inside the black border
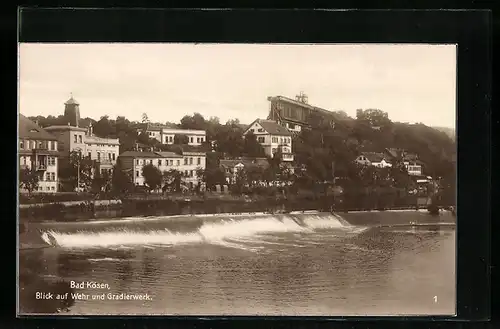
[17,43,457,316]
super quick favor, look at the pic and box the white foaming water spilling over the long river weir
[38,213,362,249]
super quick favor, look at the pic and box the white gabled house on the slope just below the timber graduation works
[243,119,294,162]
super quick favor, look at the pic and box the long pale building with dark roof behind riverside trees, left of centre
[118,151,206,188]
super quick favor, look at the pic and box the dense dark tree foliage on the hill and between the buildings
[30,109,456,204]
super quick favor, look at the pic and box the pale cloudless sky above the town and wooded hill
[19,43,456,128]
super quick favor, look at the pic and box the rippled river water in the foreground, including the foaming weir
[19,211,456,316]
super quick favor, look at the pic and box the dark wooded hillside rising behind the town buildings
[30,109,456,190]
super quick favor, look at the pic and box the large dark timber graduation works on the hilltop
[267,93,335,133]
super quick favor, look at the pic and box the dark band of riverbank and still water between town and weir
[19,192,454,222]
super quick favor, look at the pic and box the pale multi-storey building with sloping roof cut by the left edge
[18,114,59,193]
